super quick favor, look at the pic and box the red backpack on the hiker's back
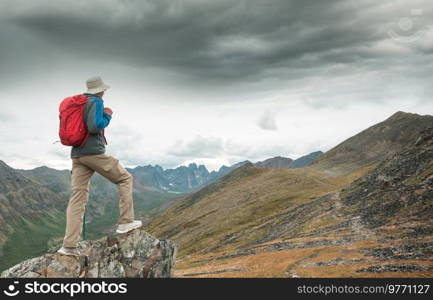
[59,95,89,147]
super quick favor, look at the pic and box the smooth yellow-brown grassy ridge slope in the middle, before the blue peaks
[147,163,359,256]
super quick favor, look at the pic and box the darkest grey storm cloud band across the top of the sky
[2,0,427,81]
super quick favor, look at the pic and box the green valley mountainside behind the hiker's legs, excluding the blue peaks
[0,161,177,269]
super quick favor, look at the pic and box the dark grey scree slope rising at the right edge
[341,123,433,238]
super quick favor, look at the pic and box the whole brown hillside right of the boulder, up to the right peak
[147,113,433,277]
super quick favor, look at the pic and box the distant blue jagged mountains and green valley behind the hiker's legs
[0,151,320,269]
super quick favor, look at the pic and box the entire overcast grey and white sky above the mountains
[0,0,433,170]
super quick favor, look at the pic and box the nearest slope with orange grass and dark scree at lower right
[171,128,433,277]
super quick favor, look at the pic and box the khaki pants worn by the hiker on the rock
[63,154,134,248]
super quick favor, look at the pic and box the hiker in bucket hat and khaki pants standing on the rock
[58,77,142,256]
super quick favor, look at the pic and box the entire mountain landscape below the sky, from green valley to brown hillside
[0,112,433,277]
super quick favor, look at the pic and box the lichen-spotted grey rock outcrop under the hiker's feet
[1,229,176,278]
